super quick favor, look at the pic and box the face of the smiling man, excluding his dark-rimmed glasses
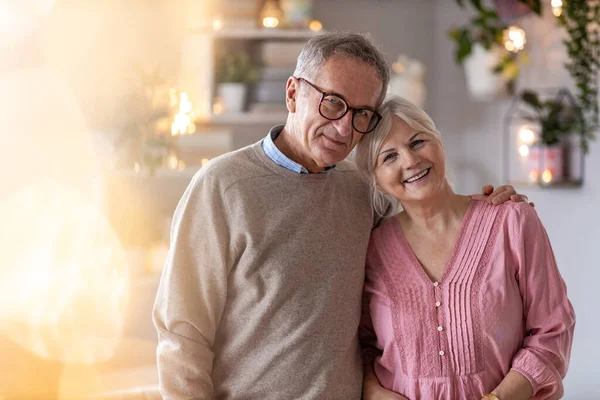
[286,57,382,172]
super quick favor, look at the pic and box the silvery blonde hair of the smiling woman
[354,96,442,217]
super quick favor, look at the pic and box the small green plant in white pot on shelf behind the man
[217,51,257,112]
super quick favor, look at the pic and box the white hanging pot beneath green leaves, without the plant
[463,44,509,101]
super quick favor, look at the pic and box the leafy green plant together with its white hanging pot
[448,0,541,100]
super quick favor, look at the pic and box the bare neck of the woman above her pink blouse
[398,183,471,233]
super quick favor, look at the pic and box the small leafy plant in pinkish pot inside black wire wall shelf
[520,90,581,183]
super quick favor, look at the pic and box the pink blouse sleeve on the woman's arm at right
[509,203,575,400]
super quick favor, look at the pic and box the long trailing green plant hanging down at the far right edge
[558,0,600,153]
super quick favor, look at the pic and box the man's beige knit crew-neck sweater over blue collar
[154,142,373,400]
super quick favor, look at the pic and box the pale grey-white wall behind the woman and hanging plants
[429,0,600,400]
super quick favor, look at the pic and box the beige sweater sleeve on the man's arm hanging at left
[153,167,232,399]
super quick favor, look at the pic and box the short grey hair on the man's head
[294,32,390,107]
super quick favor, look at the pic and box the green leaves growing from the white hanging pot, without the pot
[448,0,542,82]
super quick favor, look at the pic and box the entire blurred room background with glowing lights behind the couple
[0,0,600,399]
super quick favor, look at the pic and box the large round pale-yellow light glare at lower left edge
[0,181,128,366]
